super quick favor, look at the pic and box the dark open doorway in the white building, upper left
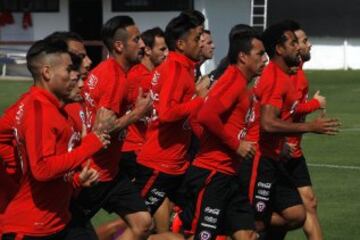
[69,0,102,67]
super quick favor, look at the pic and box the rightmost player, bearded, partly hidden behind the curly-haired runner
[285,21,326,240]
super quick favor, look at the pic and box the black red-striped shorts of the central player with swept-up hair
[134,164,184,215]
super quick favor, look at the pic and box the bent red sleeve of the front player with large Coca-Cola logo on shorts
[198,79,244,151]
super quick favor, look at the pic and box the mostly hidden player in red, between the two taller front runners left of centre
[96,27,170,240]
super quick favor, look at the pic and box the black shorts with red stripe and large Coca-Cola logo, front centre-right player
[180,166,255,239]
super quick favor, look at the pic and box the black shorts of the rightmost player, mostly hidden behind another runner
[285,156,312,188]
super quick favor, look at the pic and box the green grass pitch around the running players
[0,71,360,240]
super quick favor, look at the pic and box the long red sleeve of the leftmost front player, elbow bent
[24,101,102,181]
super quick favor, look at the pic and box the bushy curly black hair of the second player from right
[262,21,293,58]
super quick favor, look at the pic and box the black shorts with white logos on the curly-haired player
[253,157,302,223]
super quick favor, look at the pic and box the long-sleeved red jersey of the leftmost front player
[2,87,102,236]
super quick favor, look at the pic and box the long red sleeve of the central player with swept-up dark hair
[157,63,203,122]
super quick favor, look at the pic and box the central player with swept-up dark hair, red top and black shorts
[135,11,207,220]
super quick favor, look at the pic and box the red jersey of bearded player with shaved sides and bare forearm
[83,58,127,182]
